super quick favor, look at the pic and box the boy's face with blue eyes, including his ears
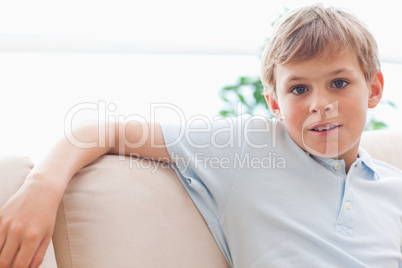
[266,52,383,166]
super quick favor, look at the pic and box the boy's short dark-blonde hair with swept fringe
[261,4,380,96]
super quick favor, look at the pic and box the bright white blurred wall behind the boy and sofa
[0,0,402,160]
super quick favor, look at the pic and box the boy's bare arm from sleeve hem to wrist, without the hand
[32,122,173,195]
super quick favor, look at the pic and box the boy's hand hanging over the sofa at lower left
[0,180,61,268]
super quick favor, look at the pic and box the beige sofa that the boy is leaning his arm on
[0,131,402,268]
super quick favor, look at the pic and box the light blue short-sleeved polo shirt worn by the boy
[162,116,402,268]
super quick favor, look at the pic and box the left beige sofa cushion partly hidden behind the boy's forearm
[0,157,57,268]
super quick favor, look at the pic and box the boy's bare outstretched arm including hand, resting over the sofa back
[0,122,173,268]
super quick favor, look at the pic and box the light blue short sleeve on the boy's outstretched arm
[161,116,249,225]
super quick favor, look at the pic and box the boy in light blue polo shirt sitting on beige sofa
[0,2,402,267]
